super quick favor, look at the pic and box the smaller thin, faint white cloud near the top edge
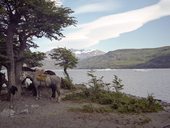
[74,1,119,15]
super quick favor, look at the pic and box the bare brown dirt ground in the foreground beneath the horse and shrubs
[0,89,170,128]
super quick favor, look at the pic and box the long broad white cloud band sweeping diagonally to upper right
[51,0,170,48]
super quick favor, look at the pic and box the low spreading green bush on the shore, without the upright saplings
[65,91,163,113]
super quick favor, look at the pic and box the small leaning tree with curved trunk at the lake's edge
[50,48,78,80]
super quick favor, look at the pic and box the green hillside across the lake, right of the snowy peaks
[77,46,170,68]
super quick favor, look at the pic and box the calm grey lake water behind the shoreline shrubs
[55,69,170,103]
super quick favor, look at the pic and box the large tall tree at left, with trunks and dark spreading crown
[0,0,76,89]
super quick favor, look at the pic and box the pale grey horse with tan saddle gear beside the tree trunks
[20,69,61,102]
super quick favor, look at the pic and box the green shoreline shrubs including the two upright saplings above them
[63,71,163,113]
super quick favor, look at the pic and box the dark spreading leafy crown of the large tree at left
[0,0,76,43]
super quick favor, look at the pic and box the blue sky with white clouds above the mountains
[35,0,170,52]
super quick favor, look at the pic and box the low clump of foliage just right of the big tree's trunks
[24,51,46,67]
